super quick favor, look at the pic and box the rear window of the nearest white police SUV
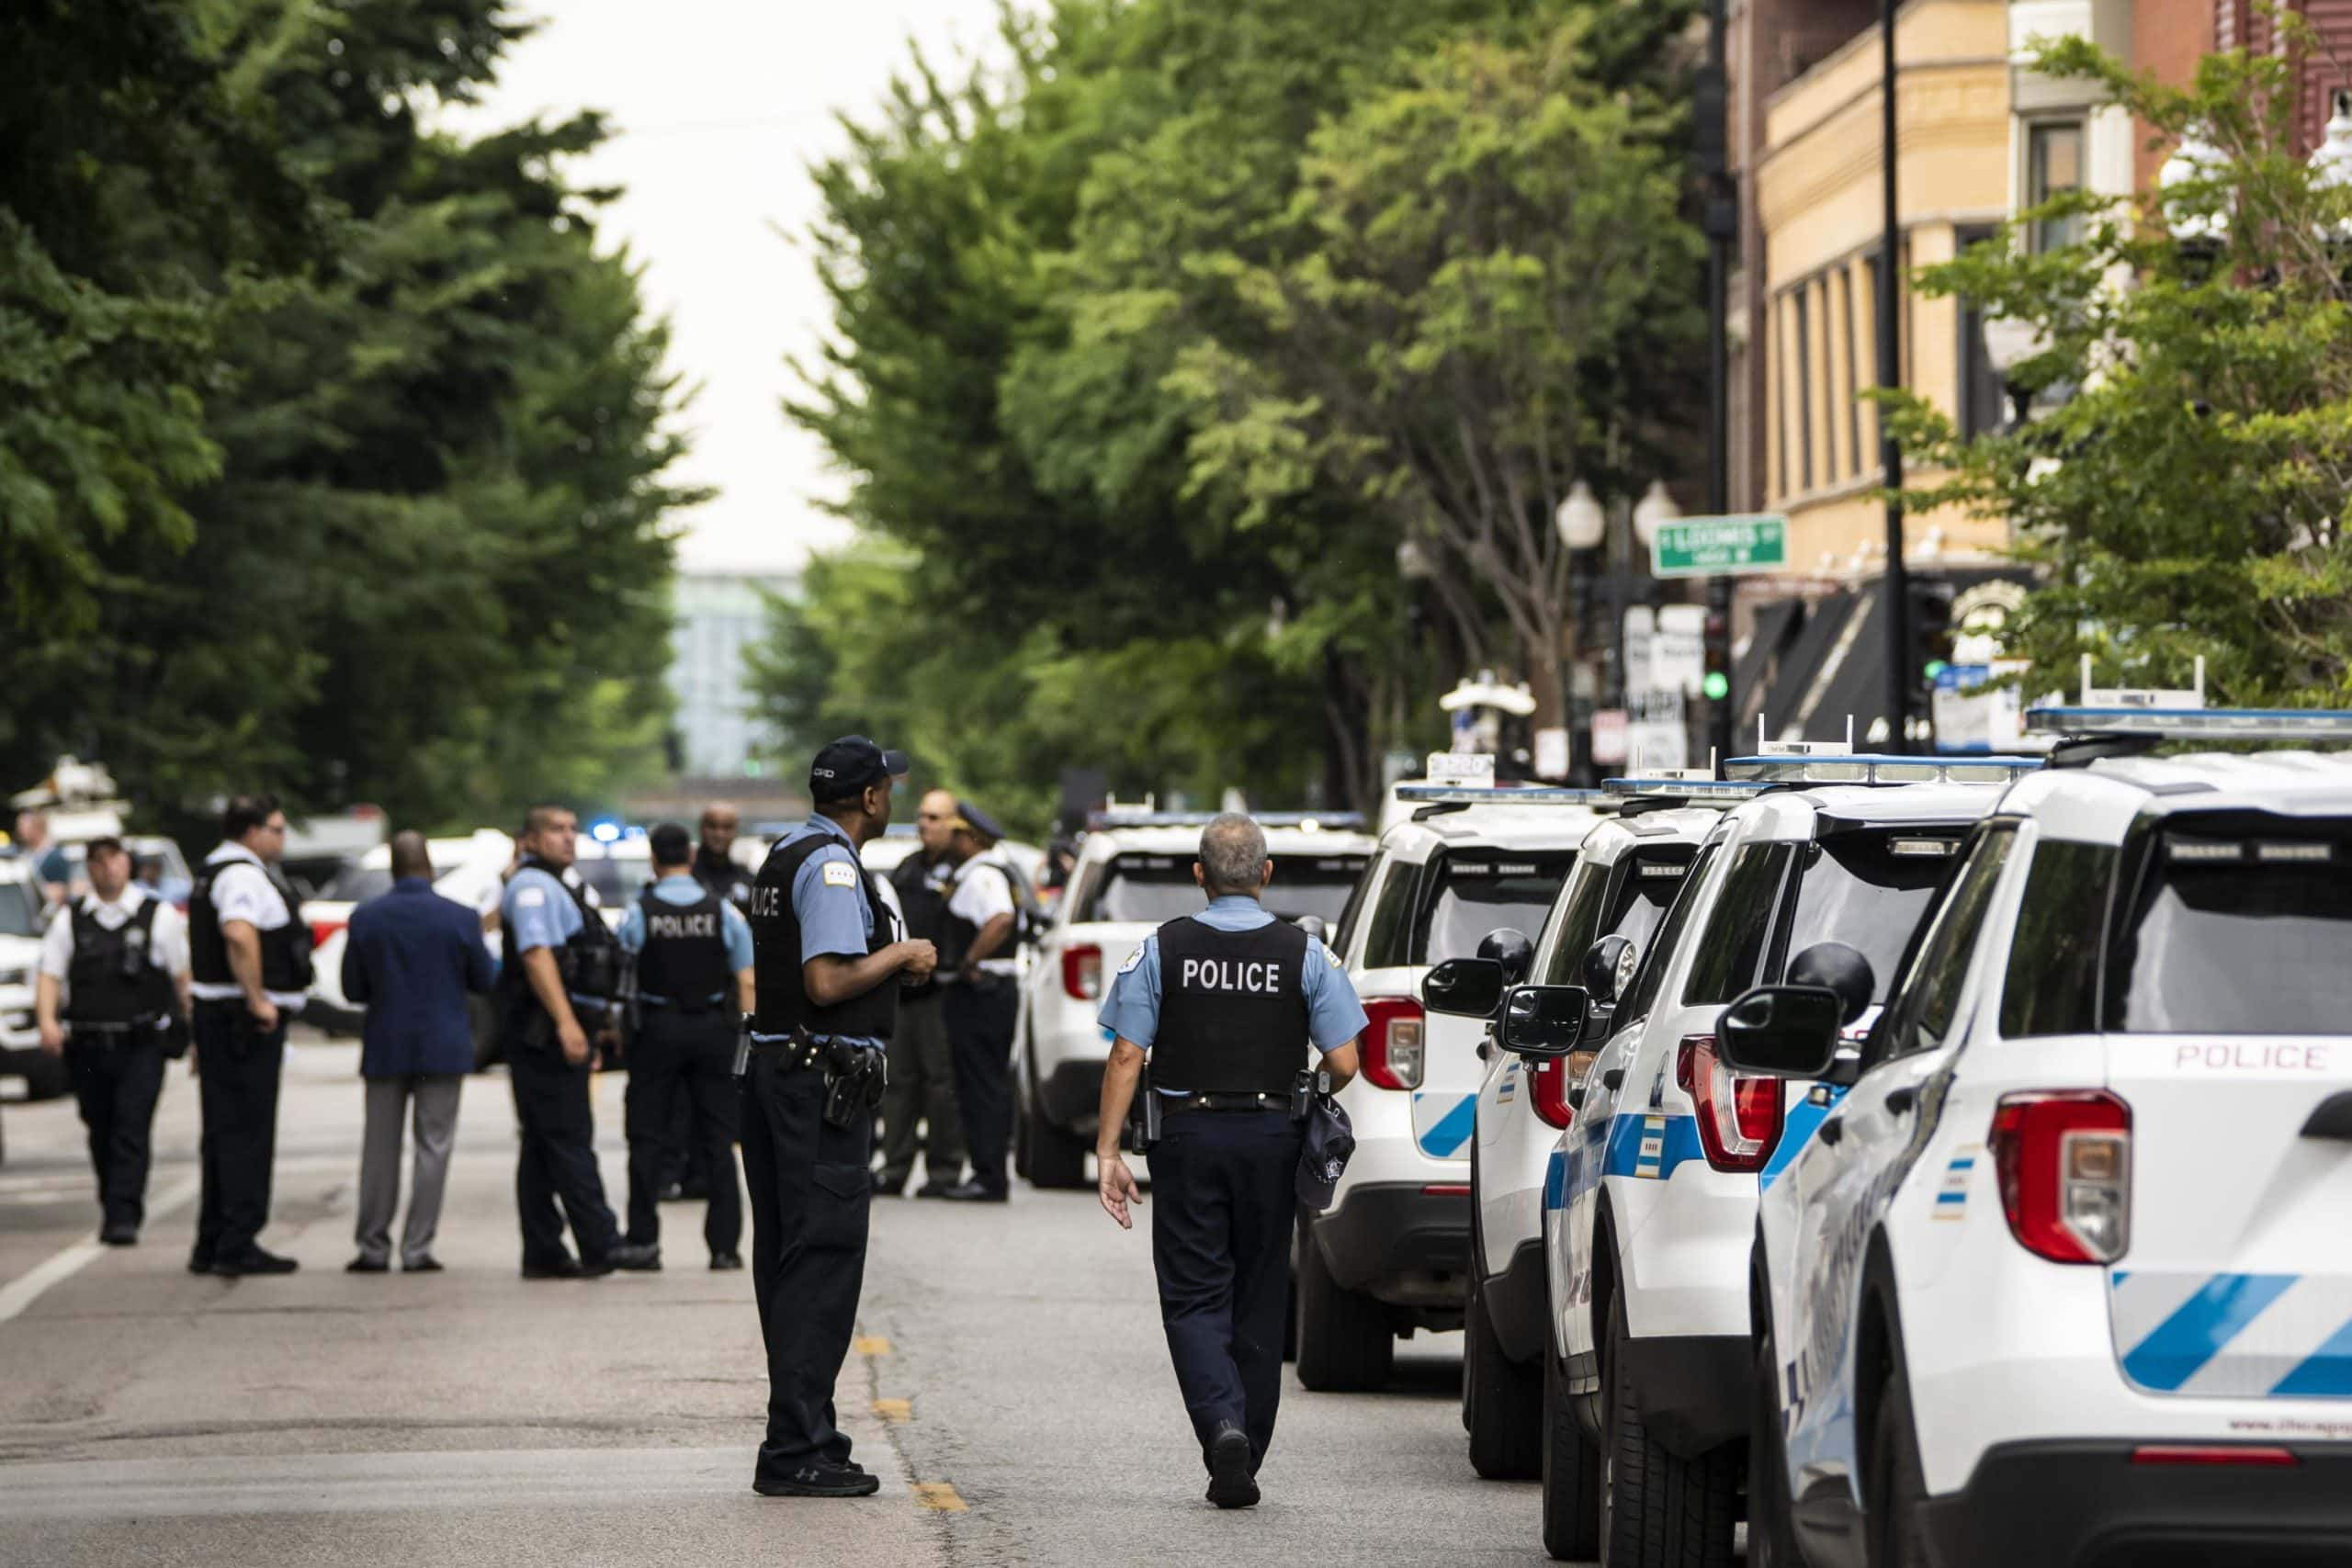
[2108,828,2352,1034]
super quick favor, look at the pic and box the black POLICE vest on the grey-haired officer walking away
[1152,915,1307,1093]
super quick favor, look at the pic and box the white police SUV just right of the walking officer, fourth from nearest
[1294,785,1601,1389]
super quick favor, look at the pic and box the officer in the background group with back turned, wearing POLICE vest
[621,823,752,1269]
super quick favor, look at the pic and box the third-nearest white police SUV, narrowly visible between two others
[1423,808,1717,1481]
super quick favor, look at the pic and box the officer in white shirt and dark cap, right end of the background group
[938,799,1021,1203]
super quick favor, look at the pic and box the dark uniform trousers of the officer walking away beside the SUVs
[1150,1110,1306,1460]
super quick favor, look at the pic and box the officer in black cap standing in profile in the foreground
[743,736,936,1497]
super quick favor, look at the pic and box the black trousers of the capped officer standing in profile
[741,1055,875,1474]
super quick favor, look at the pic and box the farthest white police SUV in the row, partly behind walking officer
[1013,811,1374,1187]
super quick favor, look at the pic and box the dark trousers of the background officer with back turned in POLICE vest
[623,1006,743,1253]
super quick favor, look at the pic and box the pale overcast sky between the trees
[463,0,997,571]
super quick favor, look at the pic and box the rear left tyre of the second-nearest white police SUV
[1600,1291,1740,1568]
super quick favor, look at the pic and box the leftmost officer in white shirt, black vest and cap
[33,840,188,1246]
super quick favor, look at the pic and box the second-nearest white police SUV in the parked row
[1545,745,2034,1565]
